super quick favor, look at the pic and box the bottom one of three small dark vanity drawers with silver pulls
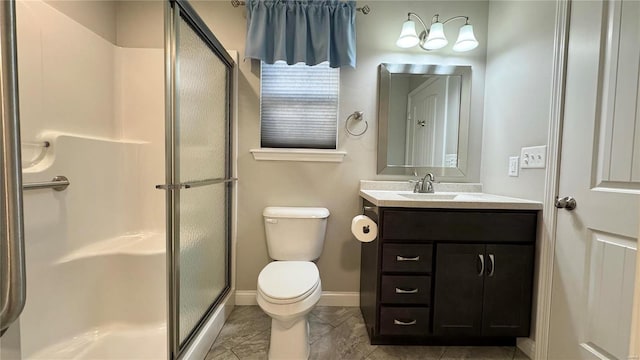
[380,306,431,336]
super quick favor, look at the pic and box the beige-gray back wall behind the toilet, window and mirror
[192,1,488,291]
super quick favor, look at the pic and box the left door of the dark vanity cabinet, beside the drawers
[434,244,486,336]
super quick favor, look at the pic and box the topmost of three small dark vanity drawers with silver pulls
[382,244,433,273]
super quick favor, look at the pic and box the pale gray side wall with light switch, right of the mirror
[481,1,556,201]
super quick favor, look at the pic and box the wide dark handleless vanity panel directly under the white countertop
[382,209,537,243]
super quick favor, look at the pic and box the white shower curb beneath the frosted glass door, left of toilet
[180,290,235,360]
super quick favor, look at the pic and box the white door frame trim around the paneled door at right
[536,0,640,360]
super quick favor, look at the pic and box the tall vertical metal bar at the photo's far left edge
[0,0,26,336]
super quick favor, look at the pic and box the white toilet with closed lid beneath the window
[257,207,329,360]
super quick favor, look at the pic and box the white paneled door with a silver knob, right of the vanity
[548,0,640,359]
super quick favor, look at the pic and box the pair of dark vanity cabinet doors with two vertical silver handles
[434,243,534,337]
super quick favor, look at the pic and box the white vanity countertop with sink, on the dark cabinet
[360,181,542,210]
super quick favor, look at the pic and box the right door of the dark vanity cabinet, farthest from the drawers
[482,245,534,337]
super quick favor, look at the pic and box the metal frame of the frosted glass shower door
[162,0,237,360]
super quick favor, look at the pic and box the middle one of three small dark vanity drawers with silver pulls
[380,275,431,306]
